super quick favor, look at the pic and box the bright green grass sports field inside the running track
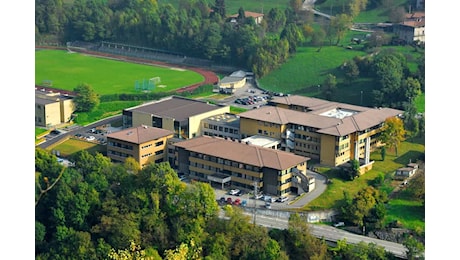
[35,50,204,95]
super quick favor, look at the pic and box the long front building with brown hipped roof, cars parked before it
[175,136,314,196]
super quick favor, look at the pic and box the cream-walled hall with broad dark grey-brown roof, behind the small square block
[122,96,230,139]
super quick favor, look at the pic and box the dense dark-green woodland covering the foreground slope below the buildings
[35,148,404,260]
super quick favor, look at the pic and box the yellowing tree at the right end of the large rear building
[380,117,406,156]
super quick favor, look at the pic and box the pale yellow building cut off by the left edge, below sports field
[35,88,75,127]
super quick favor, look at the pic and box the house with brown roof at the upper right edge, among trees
[393,12,425,44]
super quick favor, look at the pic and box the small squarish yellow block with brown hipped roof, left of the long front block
[107,125,174,168]
